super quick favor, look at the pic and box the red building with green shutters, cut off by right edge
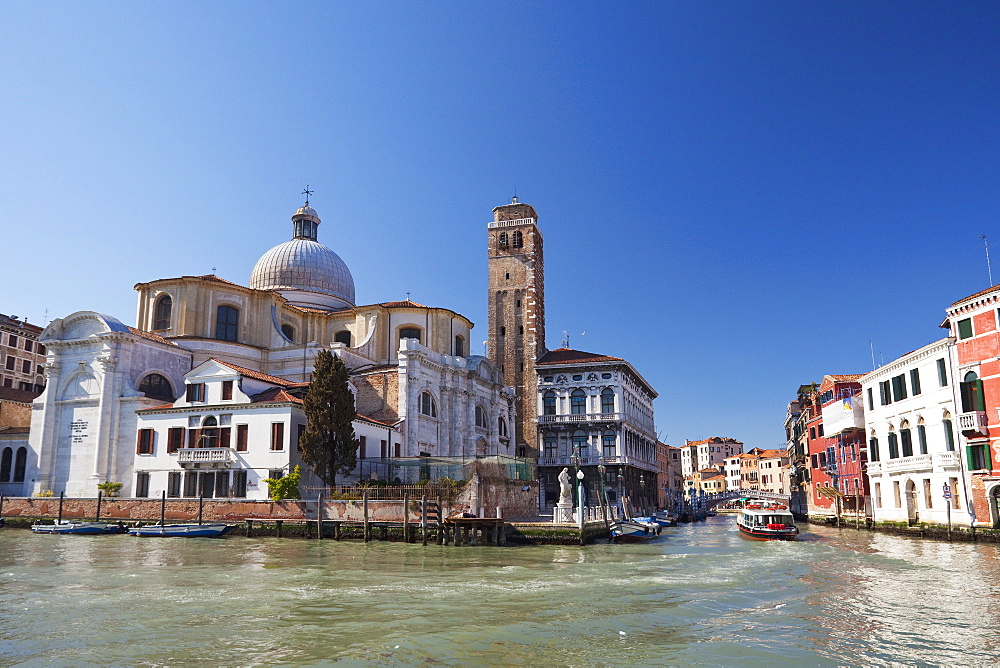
[942,286,1000,527]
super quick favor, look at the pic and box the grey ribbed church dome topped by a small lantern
[250,204,354,308]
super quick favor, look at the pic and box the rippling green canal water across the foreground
[0,517,1000,666]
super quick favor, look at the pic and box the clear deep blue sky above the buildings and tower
[0,2,1000,447]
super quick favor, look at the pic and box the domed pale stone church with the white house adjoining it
[28,202,515,498]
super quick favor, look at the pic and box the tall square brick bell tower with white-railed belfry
[486,197,546,459]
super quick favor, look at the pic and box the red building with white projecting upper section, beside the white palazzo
[805,374,868,515]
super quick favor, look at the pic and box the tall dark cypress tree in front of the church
[299,350,358,486]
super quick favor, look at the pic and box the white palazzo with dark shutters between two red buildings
[860,339,970,525]
